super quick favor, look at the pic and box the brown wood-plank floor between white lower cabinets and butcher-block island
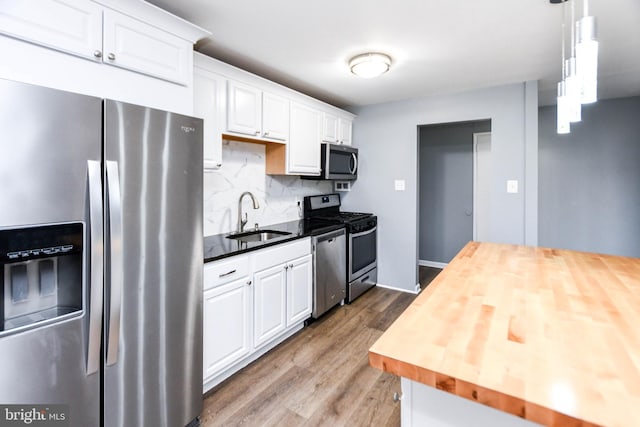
[201,287,415,427]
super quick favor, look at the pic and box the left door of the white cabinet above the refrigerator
[0,0,102,60]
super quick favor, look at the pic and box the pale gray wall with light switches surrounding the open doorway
[343,82,537,290]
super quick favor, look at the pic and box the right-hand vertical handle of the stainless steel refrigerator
[105,161,123,366]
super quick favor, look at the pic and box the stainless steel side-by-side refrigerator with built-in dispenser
[0,80,203,427]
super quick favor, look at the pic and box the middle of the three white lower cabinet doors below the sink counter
[253,264,288,348]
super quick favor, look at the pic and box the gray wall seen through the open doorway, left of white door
[418,120,491,263]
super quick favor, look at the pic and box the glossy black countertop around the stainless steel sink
[204,219,344,262]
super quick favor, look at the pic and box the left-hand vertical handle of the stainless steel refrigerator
[87,160,104,375]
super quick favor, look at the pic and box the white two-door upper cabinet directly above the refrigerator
[0,0,200,86]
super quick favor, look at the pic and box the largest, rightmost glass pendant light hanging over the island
[576,0,598,104]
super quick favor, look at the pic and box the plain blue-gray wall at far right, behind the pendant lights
[538,97,640,257]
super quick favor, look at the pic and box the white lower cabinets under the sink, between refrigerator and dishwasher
[203,238,313,392]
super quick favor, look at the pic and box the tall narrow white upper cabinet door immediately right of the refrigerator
[193,68,227,169]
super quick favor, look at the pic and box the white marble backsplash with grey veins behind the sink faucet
[204,141,332,236]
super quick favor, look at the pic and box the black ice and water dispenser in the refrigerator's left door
[0,223,84,336]
